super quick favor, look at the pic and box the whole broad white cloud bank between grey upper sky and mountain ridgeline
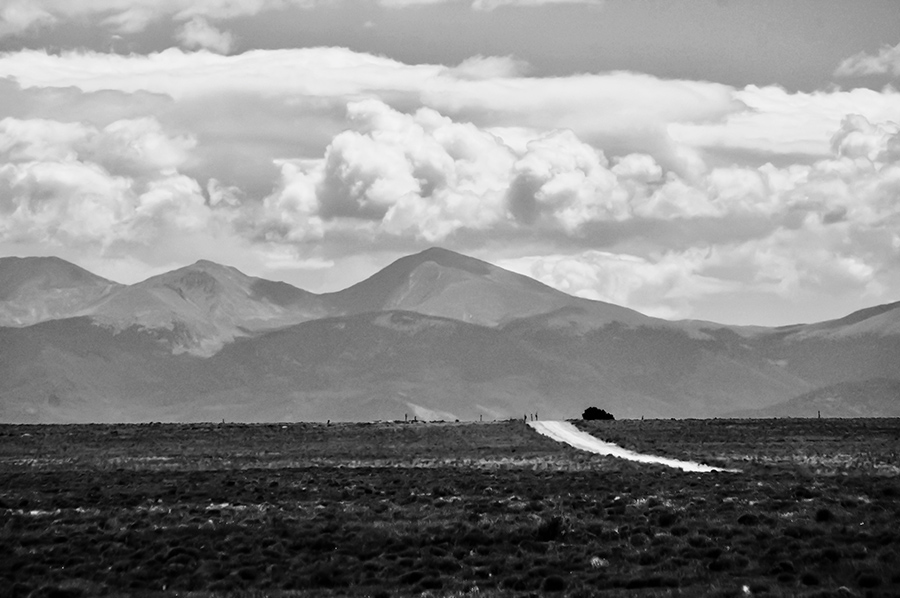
[0,48,900,323]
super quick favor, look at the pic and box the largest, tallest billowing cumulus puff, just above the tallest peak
[256,100,514,241]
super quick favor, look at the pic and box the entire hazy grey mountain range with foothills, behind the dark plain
[0,248,900,423]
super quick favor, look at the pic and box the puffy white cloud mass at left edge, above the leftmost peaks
[0,118,220,247]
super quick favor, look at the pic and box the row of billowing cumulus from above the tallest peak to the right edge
[251,100,900,264]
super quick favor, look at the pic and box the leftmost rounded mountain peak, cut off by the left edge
[0,257,121,326]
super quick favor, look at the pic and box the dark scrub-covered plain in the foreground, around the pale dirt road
[0,419,900,598]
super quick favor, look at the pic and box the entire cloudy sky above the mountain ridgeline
[0,0,900,326]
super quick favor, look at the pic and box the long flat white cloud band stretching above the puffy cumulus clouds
[0,48,744,183]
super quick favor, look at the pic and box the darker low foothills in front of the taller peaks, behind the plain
[0,311,808,421]
